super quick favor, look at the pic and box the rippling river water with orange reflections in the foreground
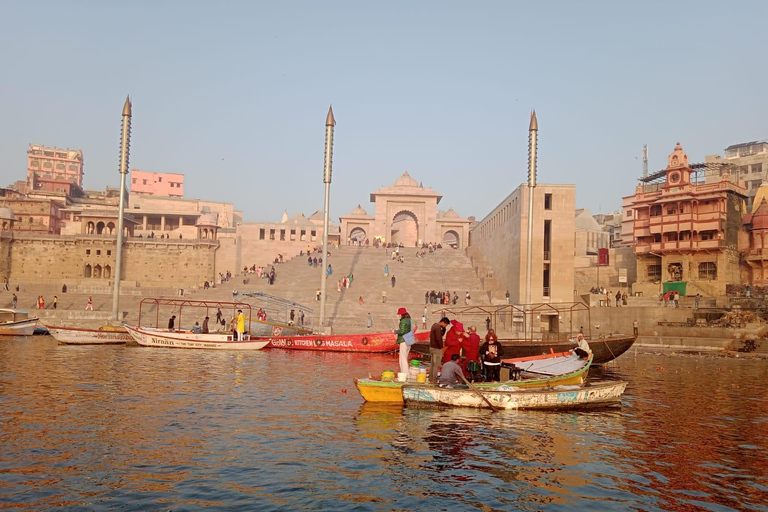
[0,337,768,511]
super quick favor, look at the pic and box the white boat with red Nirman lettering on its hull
[125,325,269,350]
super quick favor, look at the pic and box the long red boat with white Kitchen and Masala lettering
[259,331,429,353]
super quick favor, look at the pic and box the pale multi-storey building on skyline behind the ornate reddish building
[705,140,768,209]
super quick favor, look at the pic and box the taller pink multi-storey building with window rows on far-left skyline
[27,144,83,194]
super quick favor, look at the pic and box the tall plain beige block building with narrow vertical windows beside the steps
[469,184,576,304]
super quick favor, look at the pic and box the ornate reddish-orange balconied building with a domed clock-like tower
[623,143,746,296]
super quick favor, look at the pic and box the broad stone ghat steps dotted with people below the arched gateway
[18,246,489,333]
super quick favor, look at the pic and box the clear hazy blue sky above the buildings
[0,0,768,222]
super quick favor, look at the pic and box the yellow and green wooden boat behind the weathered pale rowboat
[354,357,592,403]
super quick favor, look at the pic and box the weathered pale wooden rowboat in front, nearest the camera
[402,381,627,409]
